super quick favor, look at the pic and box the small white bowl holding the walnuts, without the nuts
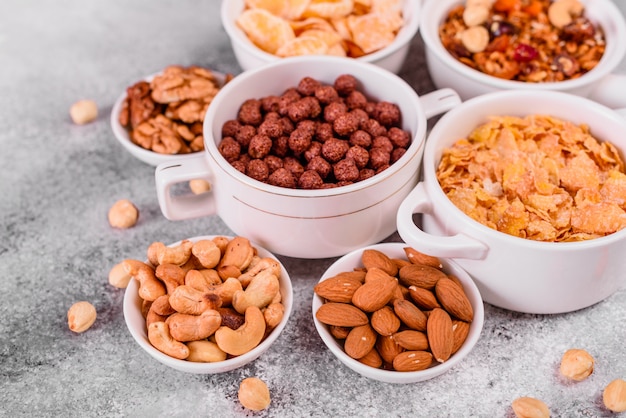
[111,70,226,166]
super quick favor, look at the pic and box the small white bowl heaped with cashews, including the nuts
[119,236,293,374]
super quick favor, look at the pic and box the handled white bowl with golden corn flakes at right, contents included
[397,90,626,314]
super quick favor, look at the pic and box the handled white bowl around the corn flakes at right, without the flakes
[397,90,626,314]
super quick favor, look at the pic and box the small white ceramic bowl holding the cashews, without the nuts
[124,235,293,374]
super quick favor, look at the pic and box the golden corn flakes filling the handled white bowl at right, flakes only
[437,115,626,241]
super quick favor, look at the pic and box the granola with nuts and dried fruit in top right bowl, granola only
[439,0,606,83]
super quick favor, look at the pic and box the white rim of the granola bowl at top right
[420,0,626,91]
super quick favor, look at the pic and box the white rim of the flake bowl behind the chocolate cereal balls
[220,0,422,66]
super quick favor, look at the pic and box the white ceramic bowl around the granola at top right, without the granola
[419,0,626,108]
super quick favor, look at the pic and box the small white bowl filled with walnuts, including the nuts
[111,65,232,166]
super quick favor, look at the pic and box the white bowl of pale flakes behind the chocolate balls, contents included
[221,0,421,73]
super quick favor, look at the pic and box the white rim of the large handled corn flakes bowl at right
[419,90,626,251]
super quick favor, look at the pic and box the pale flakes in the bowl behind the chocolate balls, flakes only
[236,0,404,58]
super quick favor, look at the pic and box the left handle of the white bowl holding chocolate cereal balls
[154,152,216,221]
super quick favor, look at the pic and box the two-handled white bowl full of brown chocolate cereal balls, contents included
[155,56,460,258]
